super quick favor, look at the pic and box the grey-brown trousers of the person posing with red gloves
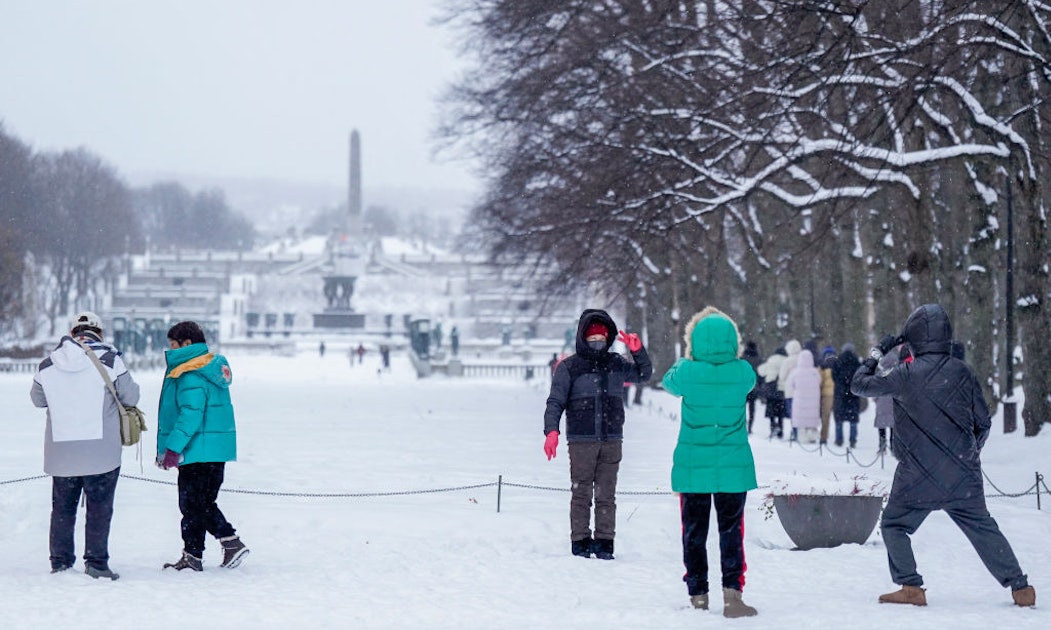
[570,441,622,541]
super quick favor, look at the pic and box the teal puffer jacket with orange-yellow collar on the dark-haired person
[157,344,238,464]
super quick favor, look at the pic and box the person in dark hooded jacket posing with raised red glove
[543,308,653,560]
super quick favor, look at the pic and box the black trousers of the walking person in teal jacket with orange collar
[179,462,234,557]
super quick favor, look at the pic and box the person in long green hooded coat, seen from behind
[662,306,758,617]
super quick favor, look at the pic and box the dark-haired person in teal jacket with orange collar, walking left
[157,322,248,571]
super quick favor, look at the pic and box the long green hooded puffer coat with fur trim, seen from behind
[663,307,758,493]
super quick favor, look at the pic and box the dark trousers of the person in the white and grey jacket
[50,466,121,569]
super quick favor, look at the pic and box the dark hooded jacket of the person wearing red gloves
[543,309,654,444]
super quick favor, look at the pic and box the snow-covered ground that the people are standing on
[0,348,1051,630]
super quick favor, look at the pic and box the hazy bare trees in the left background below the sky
[0,125,254,337]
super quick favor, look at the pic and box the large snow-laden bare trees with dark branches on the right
[444,0,1051,434]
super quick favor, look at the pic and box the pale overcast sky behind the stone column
[0,0,478,190]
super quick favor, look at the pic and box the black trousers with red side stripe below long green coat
[679,492,747,595]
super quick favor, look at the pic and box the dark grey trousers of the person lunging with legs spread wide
[880,503,1029,590]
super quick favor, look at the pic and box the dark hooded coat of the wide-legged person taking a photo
[851,304,991,509]
